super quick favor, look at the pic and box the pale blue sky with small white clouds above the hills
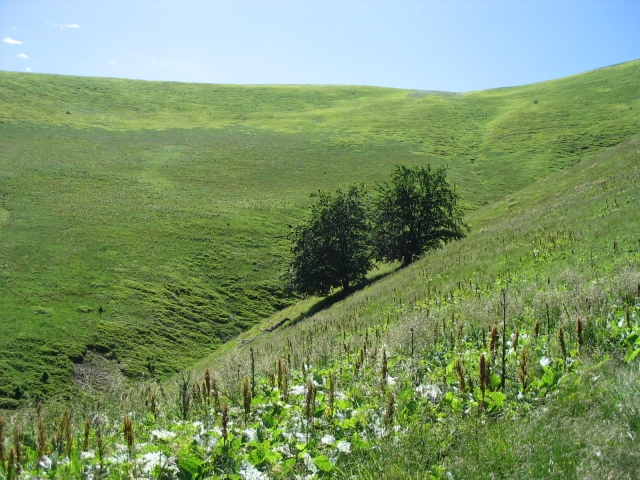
[0,0,640,91]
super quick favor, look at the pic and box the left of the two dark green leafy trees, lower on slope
[288,185,373,295]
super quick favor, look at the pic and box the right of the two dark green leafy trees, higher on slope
[373,165,468,266]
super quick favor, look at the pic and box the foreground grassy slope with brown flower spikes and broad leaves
[5,124,640,479]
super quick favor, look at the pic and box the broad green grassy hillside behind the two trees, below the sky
[0,62,640,406]
